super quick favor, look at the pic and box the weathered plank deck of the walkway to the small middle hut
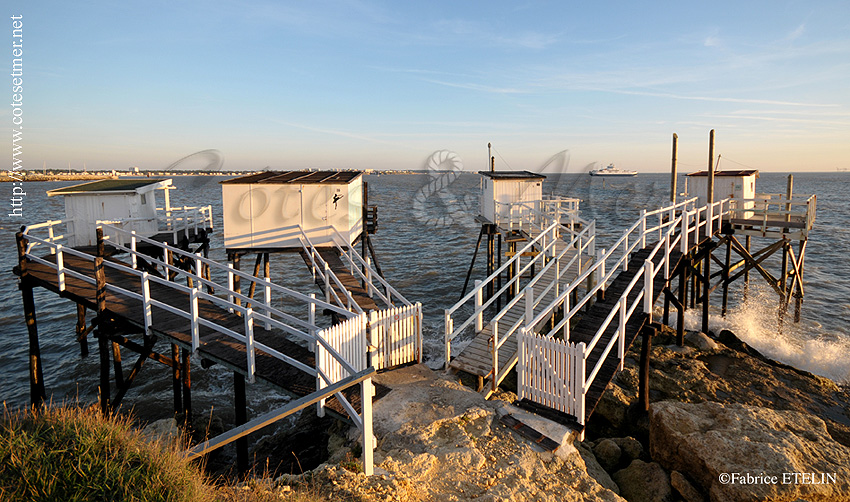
[449,230,593,384]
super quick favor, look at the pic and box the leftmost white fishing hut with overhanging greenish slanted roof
[47,178,171,247]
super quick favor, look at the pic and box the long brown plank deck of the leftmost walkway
[14,253,382,417]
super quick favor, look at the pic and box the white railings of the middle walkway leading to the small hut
[444,214,596,375]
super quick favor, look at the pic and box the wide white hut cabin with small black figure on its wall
[221,171,363,252]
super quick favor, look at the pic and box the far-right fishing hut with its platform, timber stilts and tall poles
[664,130,817,343]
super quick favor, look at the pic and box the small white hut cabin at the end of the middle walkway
[478,171,546,223]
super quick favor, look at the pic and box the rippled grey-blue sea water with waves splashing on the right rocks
[0,172,850,420]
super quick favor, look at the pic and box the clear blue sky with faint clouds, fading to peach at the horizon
[6,0,850,172]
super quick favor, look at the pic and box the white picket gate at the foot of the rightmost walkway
[517,329,584,416]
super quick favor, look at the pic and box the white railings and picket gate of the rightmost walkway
[517,198,730,432]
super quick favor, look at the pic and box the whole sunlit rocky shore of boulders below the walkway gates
[207,331,850,502]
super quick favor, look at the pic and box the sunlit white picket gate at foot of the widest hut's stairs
[369,303,422,370]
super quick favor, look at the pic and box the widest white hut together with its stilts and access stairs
[220,171,380,311]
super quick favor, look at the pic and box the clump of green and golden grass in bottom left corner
[0,406,216,502]
